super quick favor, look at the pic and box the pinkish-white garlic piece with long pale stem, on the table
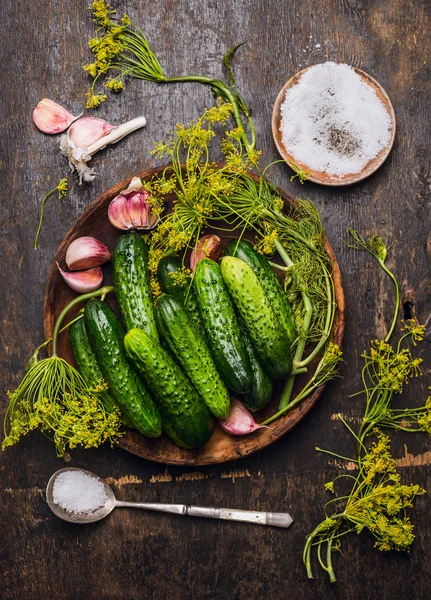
[60,117,147,185]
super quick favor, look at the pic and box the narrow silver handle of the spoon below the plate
[116,500,292,528]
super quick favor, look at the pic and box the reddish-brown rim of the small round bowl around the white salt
[272,65,396,186]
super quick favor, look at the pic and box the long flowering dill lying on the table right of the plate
[303,230,431,581]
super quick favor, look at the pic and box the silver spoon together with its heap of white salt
[46,467,292,529]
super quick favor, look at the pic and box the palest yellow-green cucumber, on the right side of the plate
[221,256,292,379]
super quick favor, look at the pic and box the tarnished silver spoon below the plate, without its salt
[46,467,292,528]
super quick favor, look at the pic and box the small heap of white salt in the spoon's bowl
[53,471,107,514]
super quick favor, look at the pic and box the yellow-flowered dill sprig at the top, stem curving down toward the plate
[84,0,256,150]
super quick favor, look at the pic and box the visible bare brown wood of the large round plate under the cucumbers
[44,167,344,466]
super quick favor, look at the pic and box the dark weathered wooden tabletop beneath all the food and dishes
[0,0,431,600]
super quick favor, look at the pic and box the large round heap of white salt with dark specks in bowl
[280,62,392,177]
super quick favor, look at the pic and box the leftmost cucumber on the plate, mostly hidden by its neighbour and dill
[69,318,134,428]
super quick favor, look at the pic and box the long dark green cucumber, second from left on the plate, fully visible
[84,299,162,437]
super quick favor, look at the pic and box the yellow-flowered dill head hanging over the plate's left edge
[2,286,120,456]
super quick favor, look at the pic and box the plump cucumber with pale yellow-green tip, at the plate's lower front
[124,329,214,448]
